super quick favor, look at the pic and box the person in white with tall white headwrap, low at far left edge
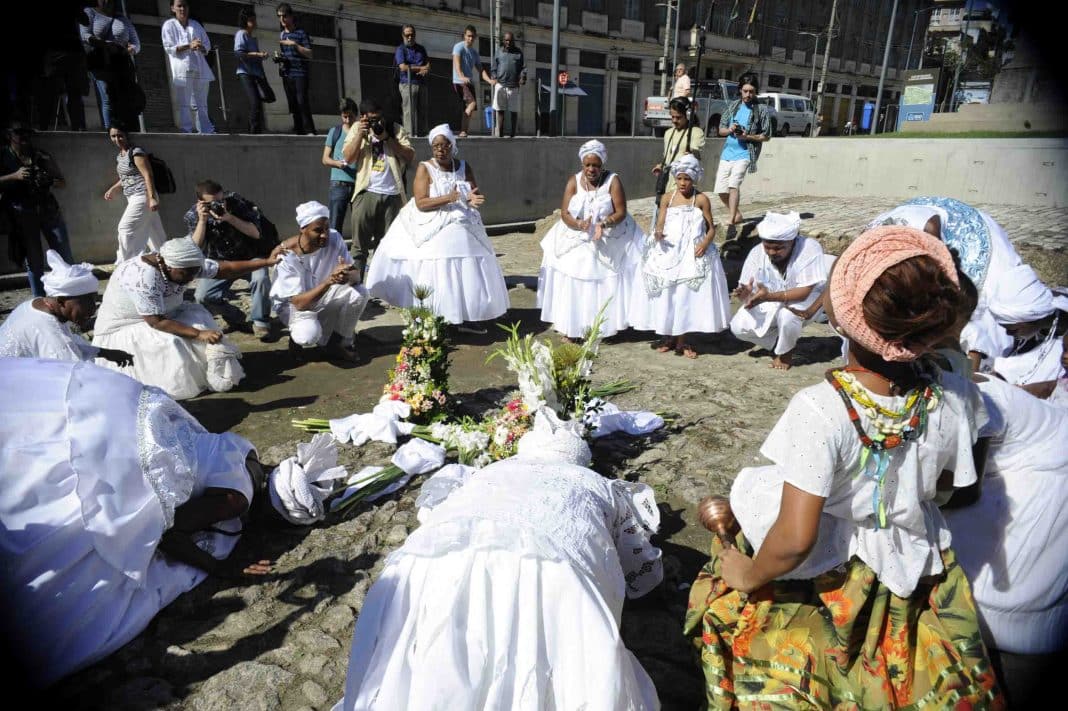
[0,250,132,365]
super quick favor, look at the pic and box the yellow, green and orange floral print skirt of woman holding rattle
[685,535,1005,711]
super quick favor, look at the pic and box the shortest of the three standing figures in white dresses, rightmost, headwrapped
[630,155,731,359]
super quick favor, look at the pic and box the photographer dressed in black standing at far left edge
[0,121,74,297]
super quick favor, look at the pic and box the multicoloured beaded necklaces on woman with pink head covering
[826,368,942,528]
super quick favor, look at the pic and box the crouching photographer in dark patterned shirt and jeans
[186,180,274,336]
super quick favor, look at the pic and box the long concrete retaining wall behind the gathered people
[0,133,1068,271]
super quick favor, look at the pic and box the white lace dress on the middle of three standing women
[537,172,644,338]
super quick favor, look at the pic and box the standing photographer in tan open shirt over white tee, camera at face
[342,99,415,282]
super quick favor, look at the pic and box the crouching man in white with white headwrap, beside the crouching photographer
[270,201,367,362]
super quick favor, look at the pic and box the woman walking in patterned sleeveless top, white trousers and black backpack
[104,121,167,264]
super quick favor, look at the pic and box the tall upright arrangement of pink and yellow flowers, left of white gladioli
[382,286,449,423]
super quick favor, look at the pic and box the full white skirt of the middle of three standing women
[537,216,643,338]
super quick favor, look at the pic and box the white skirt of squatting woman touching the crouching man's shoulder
[93,303,245,400]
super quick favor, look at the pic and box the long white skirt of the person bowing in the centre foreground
[334,550,659,711]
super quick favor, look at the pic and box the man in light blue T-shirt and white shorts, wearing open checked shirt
[716,74,771,238]
